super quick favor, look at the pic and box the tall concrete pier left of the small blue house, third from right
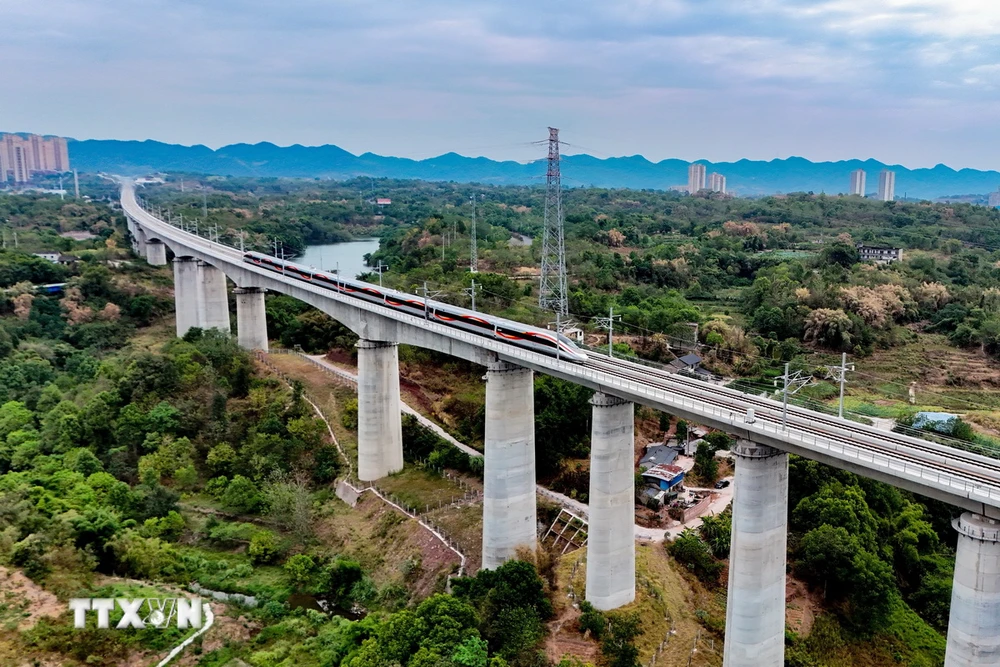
[587,392,635,611]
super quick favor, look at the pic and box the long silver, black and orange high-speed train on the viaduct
[243,252,587,362]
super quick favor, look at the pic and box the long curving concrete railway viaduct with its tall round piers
[120,179,1000,667]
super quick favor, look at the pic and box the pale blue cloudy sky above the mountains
[0,0,1000,169]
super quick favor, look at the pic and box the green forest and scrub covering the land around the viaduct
[9,175,1000,667]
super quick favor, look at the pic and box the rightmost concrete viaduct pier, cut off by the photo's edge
[944,512,1000,667]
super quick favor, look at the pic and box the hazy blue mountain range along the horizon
[58,139,1000,199]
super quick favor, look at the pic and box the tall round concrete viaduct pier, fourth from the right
[483,361,536,569]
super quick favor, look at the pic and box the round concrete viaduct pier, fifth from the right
[358,339,403,482]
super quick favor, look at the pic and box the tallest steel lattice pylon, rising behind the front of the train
[538,127,569,316]
